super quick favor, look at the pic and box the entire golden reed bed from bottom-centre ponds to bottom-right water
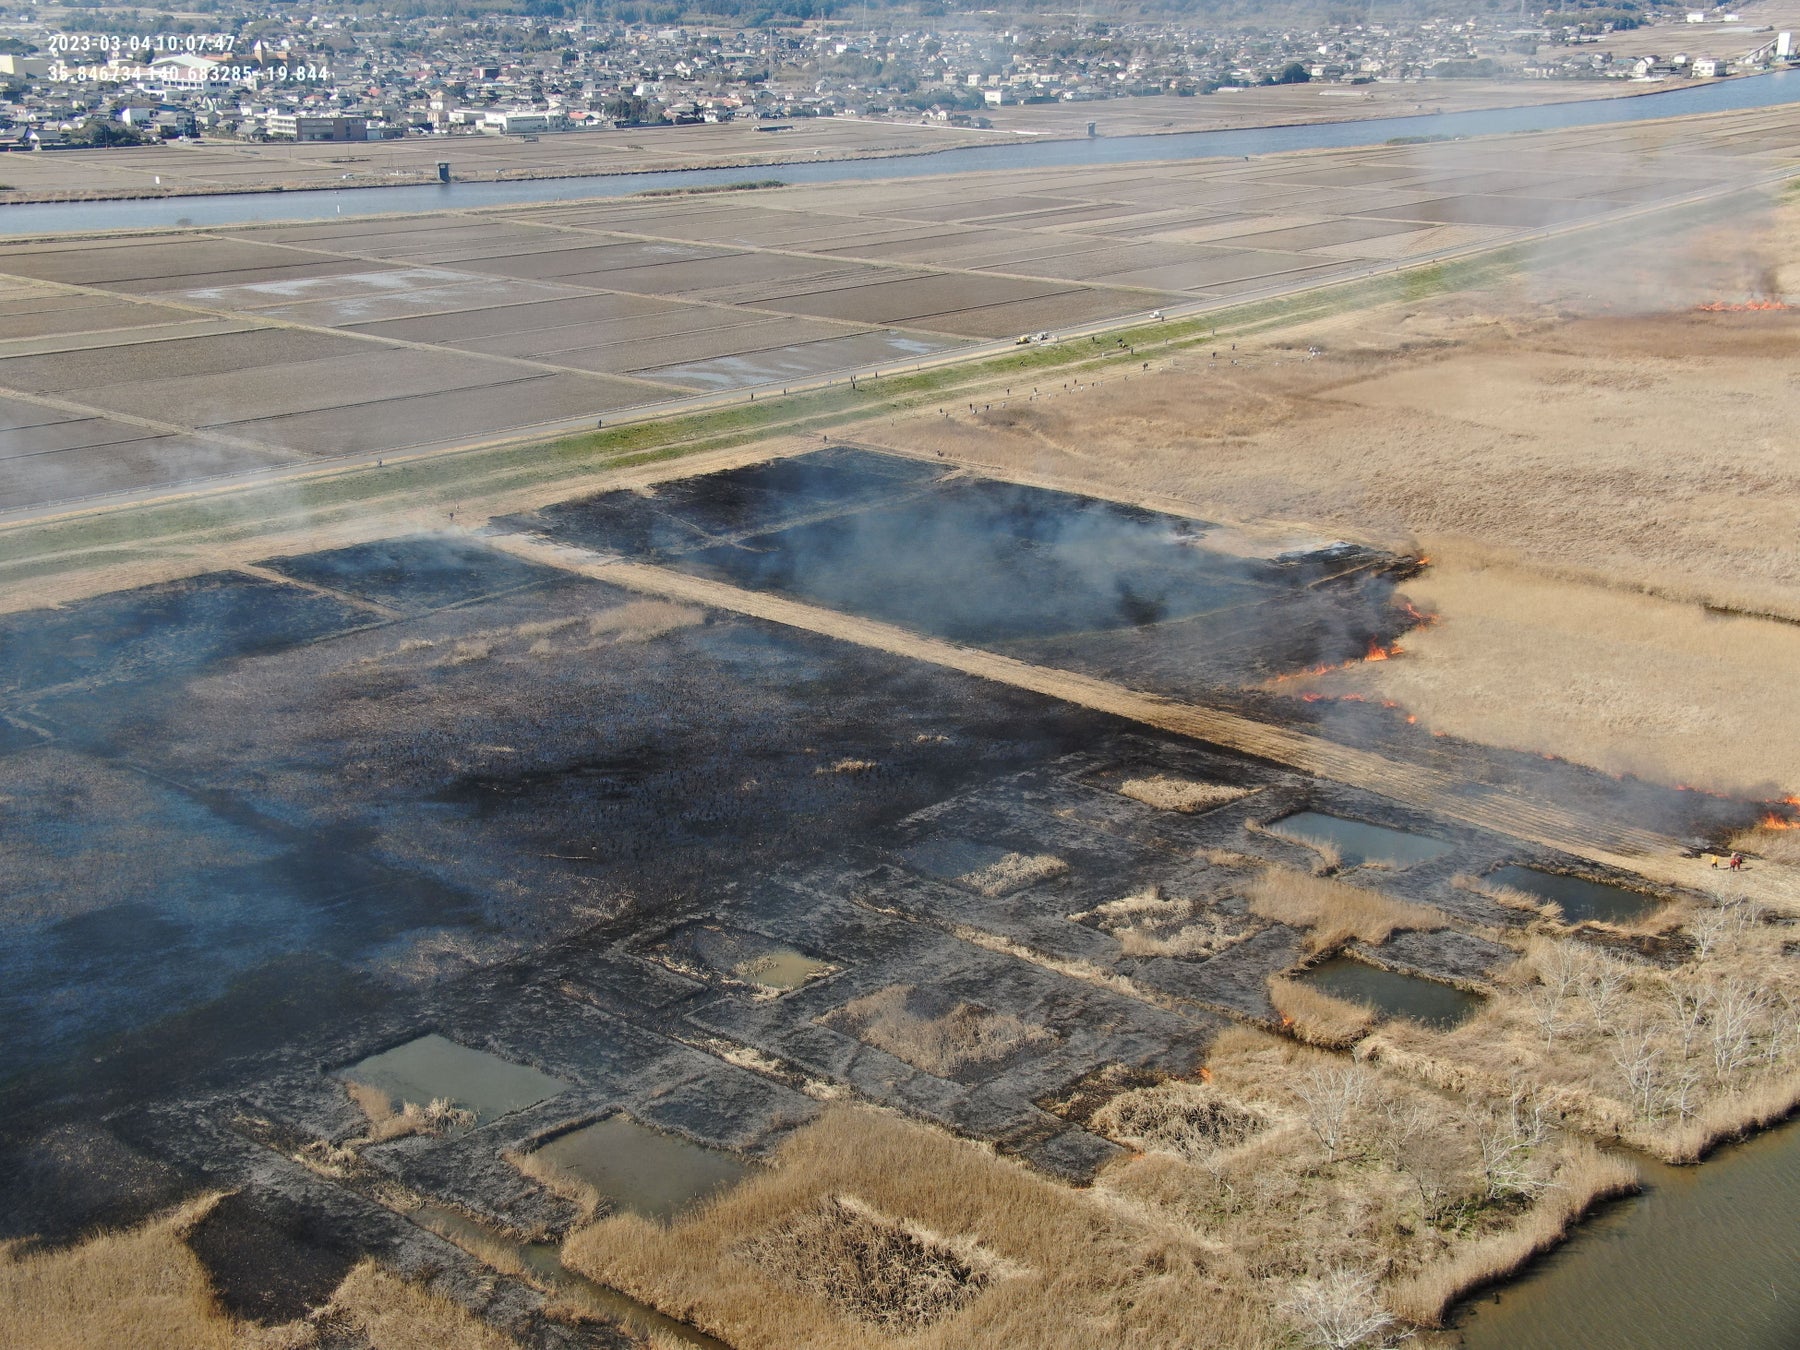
[563,1028,1636,1350]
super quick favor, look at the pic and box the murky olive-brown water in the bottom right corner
[1458,1120,1800,1350]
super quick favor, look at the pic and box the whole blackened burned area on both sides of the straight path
[0,452,1771,1345]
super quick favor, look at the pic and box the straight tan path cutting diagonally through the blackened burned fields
[486,533,1681,871]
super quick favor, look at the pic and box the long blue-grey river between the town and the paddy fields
[0,70,1800,234]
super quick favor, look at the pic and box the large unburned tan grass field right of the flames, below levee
[860,214,1800,792]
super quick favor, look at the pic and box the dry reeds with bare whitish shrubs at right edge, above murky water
[1363,904,1800,1163]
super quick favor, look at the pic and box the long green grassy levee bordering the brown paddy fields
[0,180,1771,587]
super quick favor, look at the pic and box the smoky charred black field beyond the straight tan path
[515,448,1417,695]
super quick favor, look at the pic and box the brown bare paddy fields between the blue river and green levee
[0,101,1796,509]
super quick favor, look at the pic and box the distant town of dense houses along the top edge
[0,0,1800,148]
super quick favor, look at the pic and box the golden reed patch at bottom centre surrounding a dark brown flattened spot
[563,1107,1282,1350]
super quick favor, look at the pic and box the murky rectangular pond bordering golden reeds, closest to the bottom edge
[529,1114,752,1220]
